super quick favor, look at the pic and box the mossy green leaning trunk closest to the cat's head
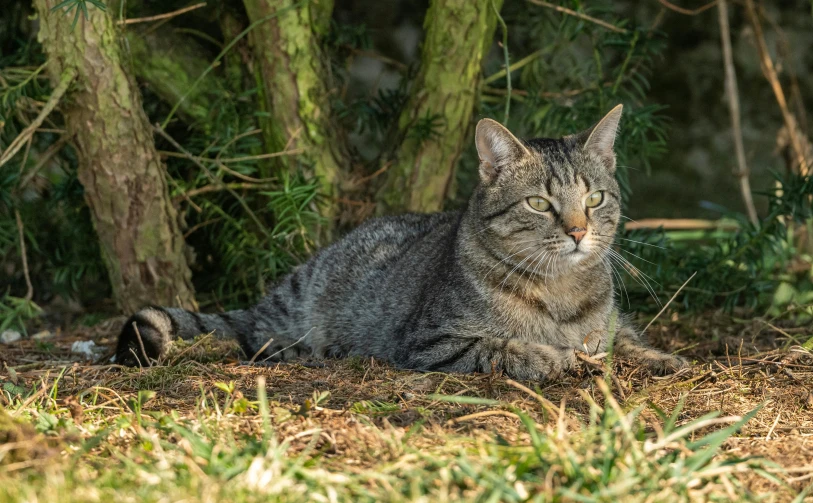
[378,0,502,212]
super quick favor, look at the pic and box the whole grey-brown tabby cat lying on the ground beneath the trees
[117,105,686,380]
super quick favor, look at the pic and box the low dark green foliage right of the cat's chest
[613,176,813,315]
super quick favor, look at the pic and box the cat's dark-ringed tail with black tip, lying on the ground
[116,307,253,366]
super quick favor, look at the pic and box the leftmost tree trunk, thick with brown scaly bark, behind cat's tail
[35,0,196,312]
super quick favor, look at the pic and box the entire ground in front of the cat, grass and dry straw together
[0,316,813,502]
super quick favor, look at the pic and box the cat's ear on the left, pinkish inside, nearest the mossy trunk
[474,119,529,182]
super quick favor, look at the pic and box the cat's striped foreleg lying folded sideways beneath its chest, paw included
[405,335,576,381]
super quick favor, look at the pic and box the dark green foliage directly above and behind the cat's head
[470,2,667,200]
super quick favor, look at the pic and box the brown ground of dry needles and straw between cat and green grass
[0,314,813,498]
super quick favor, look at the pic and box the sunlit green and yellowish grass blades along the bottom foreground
[0,380,772,502]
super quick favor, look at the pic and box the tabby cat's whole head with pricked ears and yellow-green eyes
[472,105,622,273]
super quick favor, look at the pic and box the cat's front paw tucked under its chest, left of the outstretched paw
[505,341,576,381]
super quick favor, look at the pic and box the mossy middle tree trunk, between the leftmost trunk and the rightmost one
[243,0,347,220]
